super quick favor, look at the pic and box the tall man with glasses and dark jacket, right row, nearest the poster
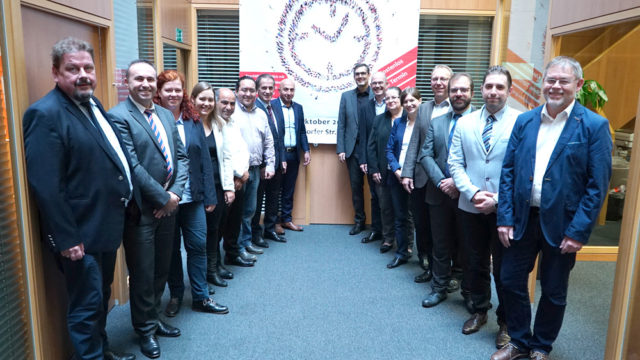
[336,64,375,235]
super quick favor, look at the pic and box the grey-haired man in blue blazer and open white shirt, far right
[491,56,612,360]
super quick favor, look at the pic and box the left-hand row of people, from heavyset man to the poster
[23,38,311,359]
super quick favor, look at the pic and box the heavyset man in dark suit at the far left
[23,38,135,359]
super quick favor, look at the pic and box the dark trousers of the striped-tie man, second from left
[123,214,176,336]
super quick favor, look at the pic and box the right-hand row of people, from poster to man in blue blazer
[336,56,612,360]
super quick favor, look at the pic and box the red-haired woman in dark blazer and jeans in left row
[154,70,229,316]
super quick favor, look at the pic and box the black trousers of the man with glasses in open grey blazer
[409,186,433,269]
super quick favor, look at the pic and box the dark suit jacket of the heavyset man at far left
[23,87,137,253]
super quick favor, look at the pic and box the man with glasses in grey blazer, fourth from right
[402,65,453,283]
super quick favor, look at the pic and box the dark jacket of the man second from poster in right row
[367,111,398,184]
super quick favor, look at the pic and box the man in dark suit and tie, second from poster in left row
[251,74,287,246]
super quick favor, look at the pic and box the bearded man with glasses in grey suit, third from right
[418,73,475,308]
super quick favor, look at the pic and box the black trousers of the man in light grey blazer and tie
[460,210,506,323]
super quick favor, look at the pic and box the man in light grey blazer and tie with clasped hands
[448,66,520,348]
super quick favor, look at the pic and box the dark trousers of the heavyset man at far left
[55,251,116,360]
